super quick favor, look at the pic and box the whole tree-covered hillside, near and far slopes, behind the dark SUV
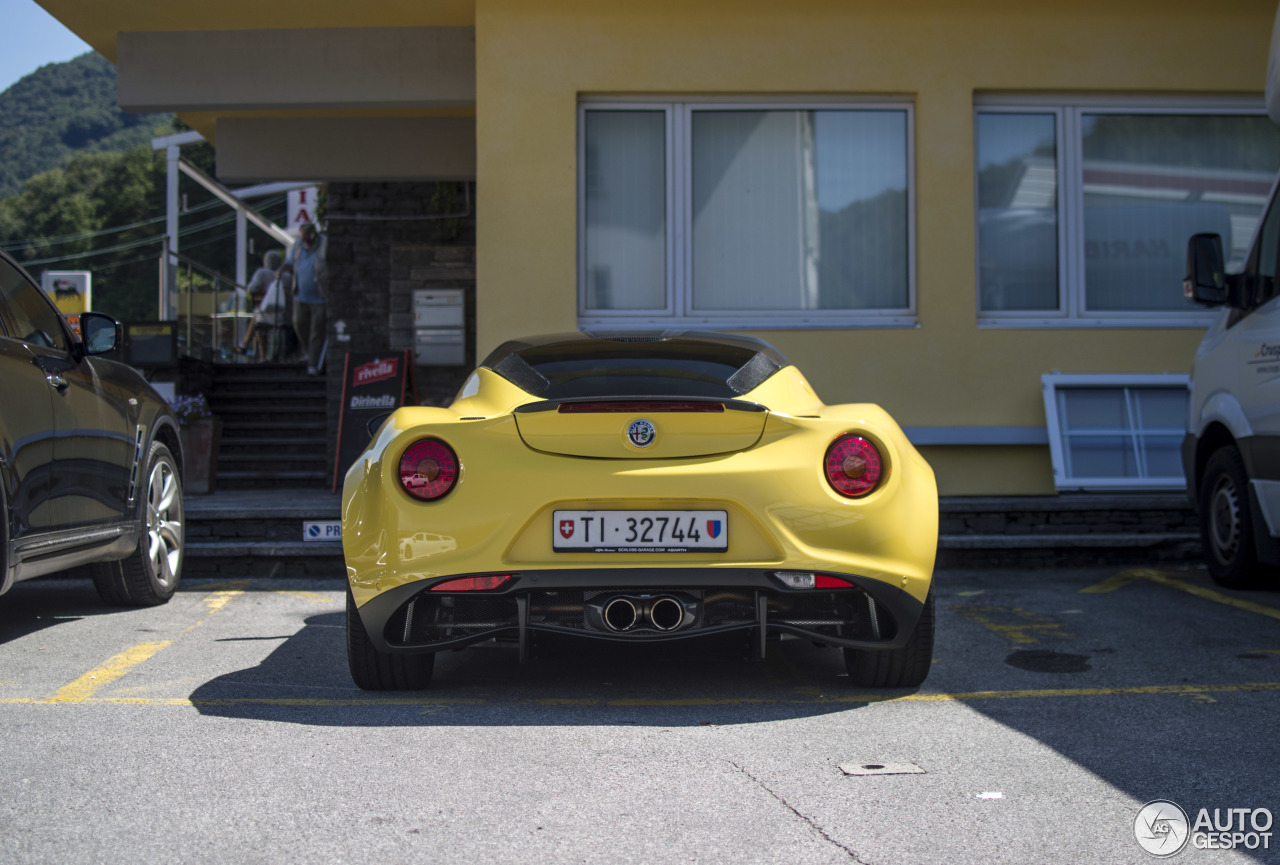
[0,54,285,321]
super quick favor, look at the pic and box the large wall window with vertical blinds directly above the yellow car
[579,101,915,328]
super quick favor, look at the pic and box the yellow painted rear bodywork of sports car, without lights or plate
[342,367,938,605]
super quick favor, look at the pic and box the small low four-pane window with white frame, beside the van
[1041,372,1188,490]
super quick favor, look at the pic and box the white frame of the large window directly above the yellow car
[577,96,919,330]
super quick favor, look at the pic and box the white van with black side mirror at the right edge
[1183,14,1280,589]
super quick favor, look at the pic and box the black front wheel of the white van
[1199,445,1262,589]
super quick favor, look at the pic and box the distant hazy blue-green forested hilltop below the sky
[0,51,170,198]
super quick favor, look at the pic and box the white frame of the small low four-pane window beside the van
[1041,372,1190,491]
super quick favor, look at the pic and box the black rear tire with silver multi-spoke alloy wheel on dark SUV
[90,441,186,607]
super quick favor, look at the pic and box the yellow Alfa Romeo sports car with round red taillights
[342,333,938,690]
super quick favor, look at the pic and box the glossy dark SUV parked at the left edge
[0,246,183,607]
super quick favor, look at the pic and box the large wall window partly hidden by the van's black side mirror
[974,100,1280,326]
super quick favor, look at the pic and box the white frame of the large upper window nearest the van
[973,96,1266,328]
